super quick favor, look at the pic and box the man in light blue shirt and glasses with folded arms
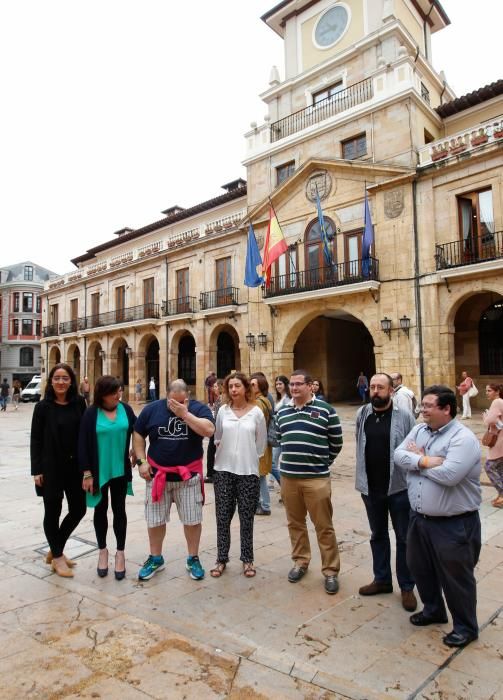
[395,385,481,647]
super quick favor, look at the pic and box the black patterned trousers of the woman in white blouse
[213,471,260,562]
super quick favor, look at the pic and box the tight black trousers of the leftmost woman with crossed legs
[44,479,86,558]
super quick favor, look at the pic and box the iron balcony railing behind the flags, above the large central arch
[262,258,379,299]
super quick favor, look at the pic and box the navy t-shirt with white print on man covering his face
[134,399,215,481]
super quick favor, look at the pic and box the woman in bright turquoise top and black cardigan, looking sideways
[79,375,136,581]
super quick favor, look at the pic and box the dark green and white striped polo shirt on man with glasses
[275,397,342,479]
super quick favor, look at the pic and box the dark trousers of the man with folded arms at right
[407,511,481,636]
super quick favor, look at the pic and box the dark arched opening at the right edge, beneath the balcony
[454,292,503,408]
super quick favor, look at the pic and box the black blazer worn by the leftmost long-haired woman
[30,396,86,496]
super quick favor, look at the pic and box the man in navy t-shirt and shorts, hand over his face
[133,379,215,581]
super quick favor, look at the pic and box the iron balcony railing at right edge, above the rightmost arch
[435,231,503,270]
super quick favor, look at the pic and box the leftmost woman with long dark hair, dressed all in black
[30,363,86,577]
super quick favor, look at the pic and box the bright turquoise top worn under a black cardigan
[86,403,133,508]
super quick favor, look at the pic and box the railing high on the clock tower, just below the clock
[270,78,373,143]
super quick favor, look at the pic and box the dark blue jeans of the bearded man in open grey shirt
[362,490,414,591]
